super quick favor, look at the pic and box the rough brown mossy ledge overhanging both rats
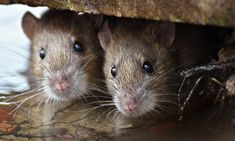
[0,0,235,26]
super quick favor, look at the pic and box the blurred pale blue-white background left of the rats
[0,4,48,93]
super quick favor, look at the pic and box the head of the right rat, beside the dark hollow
[98,19,175,117]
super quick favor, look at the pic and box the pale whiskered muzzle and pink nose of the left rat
[42,69,89,101]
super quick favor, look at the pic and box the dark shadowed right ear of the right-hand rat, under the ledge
[147,22,175,48]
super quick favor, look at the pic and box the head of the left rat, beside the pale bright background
[22,10,101,100]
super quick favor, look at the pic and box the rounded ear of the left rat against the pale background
[22,12,39,40]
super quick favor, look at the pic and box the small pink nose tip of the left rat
[55,76,69,91]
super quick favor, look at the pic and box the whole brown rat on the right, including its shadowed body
[98,18,211,117]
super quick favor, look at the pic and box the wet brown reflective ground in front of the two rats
[0,89,234,141]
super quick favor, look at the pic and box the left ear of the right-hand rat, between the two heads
[98,21,112,50]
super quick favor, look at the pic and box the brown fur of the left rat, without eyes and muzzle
[22,9,103,99]
